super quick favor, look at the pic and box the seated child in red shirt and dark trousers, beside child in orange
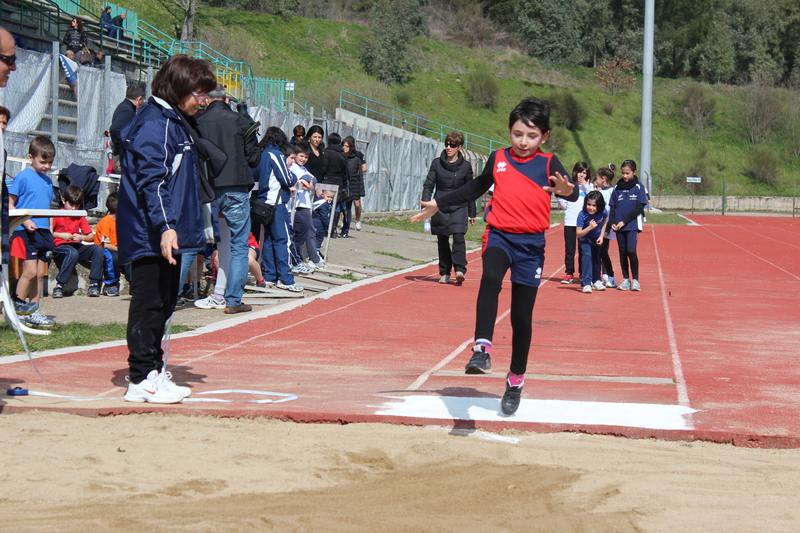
[52,185,104,298]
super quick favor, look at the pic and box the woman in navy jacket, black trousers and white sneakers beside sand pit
[117,55,217,403]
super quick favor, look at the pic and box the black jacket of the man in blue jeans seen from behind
[197,100,261,187]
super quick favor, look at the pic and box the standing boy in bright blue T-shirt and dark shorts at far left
[8,135,56,328]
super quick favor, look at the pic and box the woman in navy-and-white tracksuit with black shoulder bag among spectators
[253,126,303,292]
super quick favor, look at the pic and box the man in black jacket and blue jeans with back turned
[197,85,261,314]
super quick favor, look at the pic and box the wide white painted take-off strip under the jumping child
[375,394,696,430]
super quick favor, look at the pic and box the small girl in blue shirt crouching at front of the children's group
[576,191,608,293]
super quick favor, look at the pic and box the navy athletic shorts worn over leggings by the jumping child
[483,226,545,287]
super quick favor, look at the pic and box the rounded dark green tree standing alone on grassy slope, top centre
[361,0,427,84]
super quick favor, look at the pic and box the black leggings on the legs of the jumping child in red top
[475,248,539,375]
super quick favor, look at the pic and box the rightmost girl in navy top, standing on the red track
[609,159,647,291]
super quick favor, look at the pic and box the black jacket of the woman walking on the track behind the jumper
[422,150,475,235]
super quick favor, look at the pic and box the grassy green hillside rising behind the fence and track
[115,0,800,195]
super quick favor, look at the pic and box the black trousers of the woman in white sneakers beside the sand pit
[128,256,181,383]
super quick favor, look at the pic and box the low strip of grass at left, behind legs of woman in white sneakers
[0,322,192,356]
